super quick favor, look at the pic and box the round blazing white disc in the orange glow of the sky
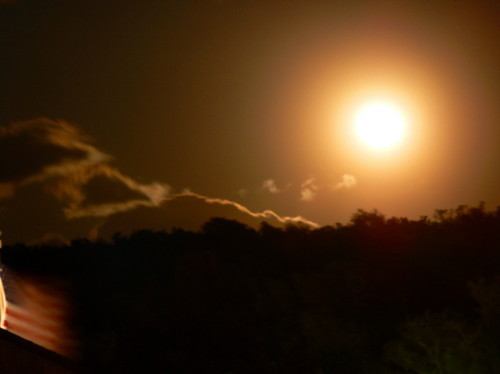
[354,103,406,150]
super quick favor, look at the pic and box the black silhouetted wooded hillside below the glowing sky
[2,205,500,374]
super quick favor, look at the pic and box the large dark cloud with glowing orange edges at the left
[0,118,169,218]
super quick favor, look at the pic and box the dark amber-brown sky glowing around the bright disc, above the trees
[0,0,500,242]
